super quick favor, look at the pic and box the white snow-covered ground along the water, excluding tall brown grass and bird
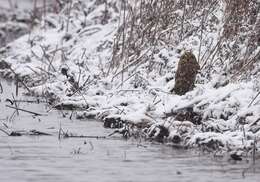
[0,0,260,158]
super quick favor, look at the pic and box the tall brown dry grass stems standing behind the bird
[109,0,260,82]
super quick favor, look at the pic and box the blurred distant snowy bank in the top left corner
[0,0,58,48]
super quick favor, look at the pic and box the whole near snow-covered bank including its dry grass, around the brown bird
[0,0,260,156]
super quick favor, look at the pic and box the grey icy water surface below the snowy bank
[0,80,260,182]
